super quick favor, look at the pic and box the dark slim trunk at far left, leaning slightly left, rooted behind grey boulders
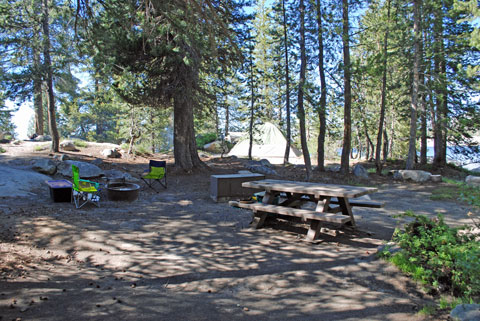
[42,0,60,152]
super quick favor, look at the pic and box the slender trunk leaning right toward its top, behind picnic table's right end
[375,0,390,174]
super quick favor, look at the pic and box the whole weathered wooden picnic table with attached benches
[234,179,383,240]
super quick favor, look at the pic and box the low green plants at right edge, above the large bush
[430,178,480,208]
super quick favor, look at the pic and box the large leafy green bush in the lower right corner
[385,212,480,298]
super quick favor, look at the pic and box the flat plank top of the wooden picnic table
[242,179,378,198]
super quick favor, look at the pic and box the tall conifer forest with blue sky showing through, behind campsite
[0,0,480,178]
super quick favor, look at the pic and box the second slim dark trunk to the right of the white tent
[316,0,327,172]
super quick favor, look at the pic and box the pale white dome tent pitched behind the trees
[228,123,303,164]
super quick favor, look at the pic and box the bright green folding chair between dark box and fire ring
[72,165,100,208]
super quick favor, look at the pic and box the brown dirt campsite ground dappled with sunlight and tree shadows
[0,143,470,321]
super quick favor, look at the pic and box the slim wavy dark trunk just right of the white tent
[297,0,312,181]
